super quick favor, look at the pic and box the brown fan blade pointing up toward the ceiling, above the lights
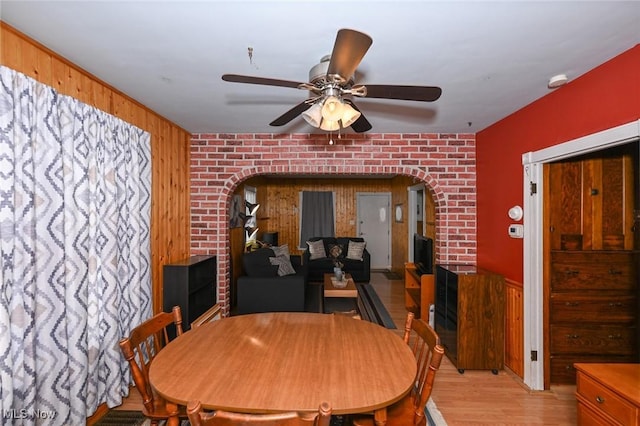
[327,28,373,80]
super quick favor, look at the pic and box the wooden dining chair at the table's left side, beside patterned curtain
[119,306,186,426]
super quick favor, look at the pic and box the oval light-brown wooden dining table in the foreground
[149,312,417,424]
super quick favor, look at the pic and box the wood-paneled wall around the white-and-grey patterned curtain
[0,22,190,312]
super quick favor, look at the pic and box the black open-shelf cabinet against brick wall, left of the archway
[163,256,217,331]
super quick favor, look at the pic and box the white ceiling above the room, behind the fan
[0,0,640,133]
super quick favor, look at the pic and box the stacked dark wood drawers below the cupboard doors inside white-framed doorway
[548,250,640,383]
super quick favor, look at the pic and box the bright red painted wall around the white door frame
[476,45,640,283]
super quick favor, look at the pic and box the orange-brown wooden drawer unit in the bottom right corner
[575,363,640,425]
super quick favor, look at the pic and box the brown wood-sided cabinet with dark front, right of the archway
[435,265,505,373]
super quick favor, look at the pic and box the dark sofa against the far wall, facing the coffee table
[302,237,371,283]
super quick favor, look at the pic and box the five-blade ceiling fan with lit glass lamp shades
[222,29,442,133]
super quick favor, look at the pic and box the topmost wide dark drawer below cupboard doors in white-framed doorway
[551,251,637,292]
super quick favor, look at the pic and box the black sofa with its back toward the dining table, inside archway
[236,248,323,314]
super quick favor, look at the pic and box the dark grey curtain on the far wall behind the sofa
[299,191,335,247]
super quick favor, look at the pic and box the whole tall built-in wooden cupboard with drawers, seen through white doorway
[545,144,640,384]
